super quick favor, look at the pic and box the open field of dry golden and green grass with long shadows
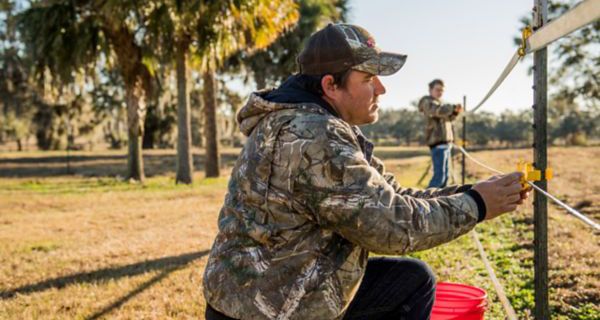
[0,147,600,319]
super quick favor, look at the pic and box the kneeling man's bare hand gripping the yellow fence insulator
[473,172,529,220]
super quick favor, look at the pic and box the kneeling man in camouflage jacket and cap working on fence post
[204,25,525,320]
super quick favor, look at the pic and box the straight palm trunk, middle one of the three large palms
[175,44,194,184]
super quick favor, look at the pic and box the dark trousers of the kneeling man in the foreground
[206,257,435,320]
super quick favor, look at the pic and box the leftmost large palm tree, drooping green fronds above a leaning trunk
[19,0,155,182]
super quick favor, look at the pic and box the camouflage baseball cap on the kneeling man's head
[298,24,406,76]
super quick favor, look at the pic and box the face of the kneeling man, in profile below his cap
[329,70,385,125]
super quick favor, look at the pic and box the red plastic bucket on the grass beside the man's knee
[431,282,487,320]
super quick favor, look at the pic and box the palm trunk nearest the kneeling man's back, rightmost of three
[203,68,219,178]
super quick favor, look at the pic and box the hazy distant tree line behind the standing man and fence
[363,100,600,147]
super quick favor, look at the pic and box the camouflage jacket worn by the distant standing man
[419,96,458,146]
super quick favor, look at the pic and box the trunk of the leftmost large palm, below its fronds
[126,80,146,182]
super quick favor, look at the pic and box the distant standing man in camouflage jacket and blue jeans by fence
[419,79,462,188]
